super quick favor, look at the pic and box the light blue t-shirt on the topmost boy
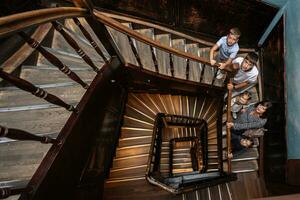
[217,36,239,61]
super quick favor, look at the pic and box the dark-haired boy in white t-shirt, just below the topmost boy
[224,52,258,90]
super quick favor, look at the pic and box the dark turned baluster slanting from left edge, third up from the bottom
[0,69,76,111]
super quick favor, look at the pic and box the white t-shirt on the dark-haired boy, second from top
[232,57,258,84]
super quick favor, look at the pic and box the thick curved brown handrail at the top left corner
[0,7,88,38]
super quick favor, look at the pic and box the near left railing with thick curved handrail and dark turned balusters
[0,7,112,199]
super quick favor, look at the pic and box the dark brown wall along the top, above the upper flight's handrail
[93,0,277,47]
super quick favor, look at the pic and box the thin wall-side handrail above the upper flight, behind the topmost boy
[97,11,255,53]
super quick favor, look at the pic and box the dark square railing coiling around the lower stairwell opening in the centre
[146,113,236,194]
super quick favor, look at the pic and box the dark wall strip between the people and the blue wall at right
[261,19,287,195]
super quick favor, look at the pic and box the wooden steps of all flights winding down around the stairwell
[0,8,265,200]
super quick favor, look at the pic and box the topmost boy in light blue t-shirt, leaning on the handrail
[209,28,241,79]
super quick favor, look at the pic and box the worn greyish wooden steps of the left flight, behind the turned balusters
[0,19,108,199]
